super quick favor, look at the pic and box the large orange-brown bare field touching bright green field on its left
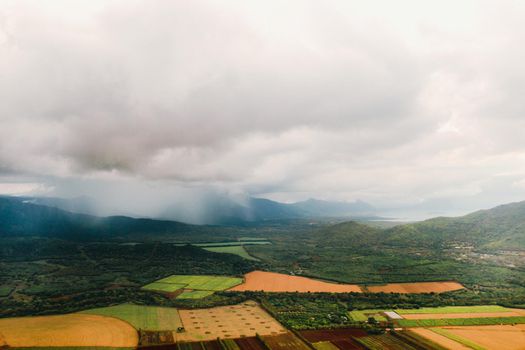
[230,271,361,293]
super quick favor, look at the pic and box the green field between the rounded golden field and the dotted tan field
[81,304,182,331]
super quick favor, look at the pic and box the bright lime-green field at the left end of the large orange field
[154,275,242,291]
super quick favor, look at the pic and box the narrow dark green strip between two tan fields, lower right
[395,316,525,327]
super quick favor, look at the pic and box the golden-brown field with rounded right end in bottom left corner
[0,314,139,347]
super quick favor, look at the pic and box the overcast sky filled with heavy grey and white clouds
[0,0,525,219]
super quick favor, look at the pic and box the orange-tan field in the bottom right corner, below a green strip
[443,324,525,350]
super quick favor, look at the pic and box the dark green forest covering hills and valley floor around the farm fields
[0,198,525,329]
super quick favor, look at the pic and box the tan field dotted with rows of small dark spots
[173,301,287,342]
